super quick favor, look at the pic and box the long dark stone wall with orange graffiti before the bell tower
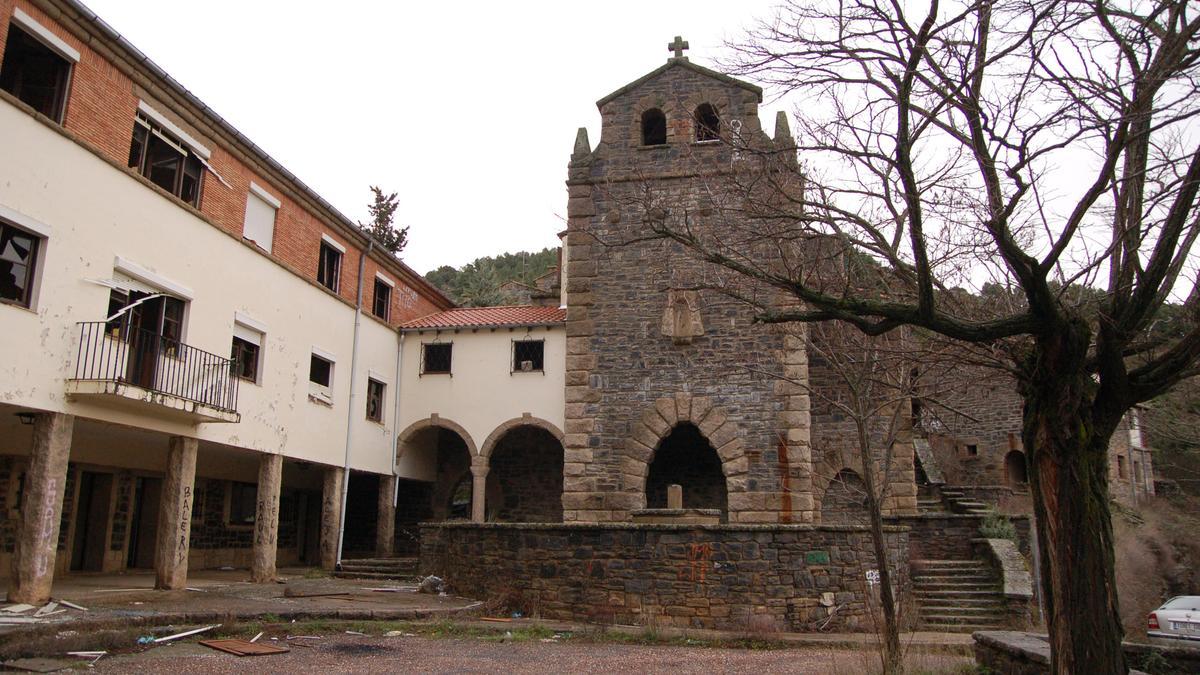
[420,522,911,631]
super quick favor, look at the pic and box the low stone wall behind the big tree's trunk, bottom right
[973,631,1200,675]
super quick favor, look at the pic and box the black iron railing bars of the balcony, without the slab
[74,321,239,412]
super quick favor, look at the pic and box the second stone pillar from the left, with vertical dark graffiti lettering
[154,436,200,591]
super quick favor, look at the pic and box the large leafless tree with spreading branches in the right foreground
[646,0,1200,673]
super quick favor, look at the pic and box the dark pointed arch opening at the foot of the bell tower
[646,424,728,521]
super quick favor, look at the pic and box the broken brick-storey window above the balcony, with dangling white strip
[128,110,204,207]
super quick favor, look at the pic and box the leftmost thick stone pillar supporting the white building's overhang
[8,413,74,604]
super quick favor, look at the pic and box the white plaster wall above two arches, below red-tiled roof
[398,325,566,478]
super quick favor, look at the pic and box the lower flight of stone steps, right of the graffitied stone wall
[912,560,1006,633]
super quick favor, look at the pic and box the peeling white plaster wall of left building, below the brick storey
[0,102,396,472]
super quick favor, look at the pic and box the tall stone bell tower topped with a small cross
[563,37,814,522]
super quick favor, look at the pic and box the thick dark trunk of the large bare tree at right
[1022,322,1128,675]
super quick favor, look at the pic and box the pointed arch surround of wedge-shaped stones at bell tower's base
[622,393,749,509]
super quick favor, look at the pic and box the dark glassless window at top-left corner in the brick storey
[0,22,71,124]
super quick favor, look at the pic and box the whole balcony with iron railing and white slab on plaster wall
[67,321,241,423]
